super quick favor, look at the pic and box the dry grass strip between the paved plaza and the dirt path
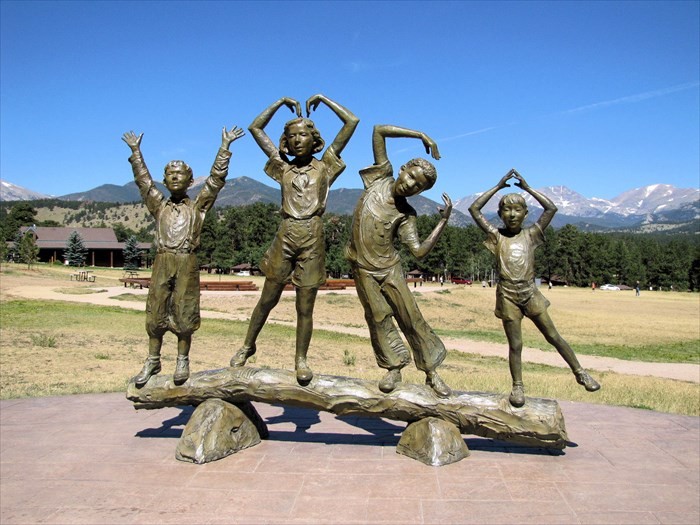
[0,300,700,415]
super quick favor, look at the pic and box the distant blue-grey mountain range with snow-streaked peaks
[0,176,700,231]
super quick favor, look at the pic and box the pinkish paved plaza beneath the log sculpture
[0,394,700,525]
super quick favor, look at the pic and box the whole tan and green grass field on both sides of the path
[0,265,700,415]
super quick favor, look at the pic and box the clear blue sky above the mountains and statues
[0,0,700,200]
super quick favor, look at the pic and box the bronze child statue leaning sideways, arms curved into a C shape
[346,125,452,397]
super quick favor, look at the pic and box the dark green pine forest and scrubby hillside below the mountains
[0,200,700,291]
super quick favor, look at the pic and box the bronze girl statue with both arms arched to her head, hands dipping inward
[231,94,359,384]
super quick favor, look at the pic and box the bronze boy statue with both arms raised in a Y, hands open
[122,127,244,387]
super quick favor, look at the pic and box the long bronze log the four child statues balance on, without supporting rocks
[127,367,568,449]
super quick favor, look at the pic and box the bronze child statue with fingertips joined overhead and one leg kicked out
[469,169,600,407]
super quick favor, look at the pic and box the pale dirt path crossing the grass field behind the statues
[3,285,700,383]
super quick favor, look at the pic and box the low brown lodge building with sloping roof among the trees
[20,226,151,268]
